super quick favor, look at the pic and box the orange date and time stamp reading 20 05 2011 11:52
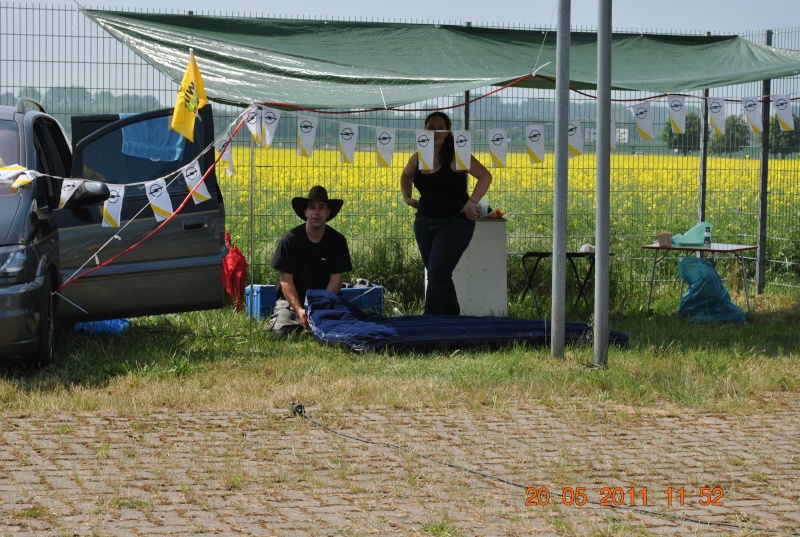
[525,487,725,507]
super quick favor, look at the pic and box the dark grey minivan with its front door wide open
[0,99,227,364]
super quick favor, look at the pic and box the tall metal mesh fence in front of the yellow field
[0,4,800,310]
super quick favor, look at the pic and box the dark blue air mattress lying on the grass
[306,289,628,351]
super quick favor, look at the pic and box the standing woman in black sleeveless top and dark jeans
[400,112,492,315]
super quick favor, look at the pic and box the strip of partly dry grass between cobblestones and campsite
[0,295,800,412]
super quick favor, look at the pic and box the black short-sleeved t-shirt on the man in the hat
[272,224,353,303]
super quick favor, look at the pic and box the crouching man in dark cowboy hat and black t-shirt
[268,186,353,334]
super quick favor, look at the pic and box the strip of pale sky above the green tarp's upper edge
[61,0,800,33]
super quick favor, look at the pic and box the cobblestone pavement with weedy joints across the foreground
[0,404,800,536]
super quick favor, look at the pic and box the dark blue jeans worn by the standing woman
[414,213,475,315]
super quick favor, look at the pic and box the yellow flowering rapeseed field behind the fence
[218,148,800,251]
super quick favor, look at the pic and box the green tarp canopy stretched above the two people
[84,10,800,108]
